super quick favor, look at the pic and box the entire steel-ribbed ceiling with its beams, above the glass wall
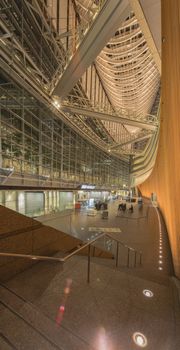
[0,0,161,185]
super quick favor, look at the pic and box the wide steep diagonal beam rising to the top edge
[53,0,130,98]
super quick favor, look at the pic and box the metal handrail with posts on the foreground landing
[0,233,142,283]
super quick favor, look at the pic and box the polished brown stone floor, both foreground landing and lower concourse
[0,201,180,350]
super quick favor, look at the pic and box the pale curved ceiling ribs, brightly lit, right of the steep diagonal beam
[96,13,160,116]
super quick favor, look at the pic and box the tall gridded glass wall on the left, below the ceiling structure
[0,72,129,190]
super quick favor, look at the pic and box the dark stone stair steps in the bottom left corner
[0,285,93,350]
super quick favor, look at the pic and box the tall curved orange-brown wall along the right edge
[139,0,180,278]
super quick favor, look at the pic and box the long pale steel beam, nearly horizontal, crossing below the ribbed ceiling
[61,106,157,130]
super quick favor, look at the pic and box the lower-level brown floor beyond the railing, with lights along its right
[37,199,173,280]
